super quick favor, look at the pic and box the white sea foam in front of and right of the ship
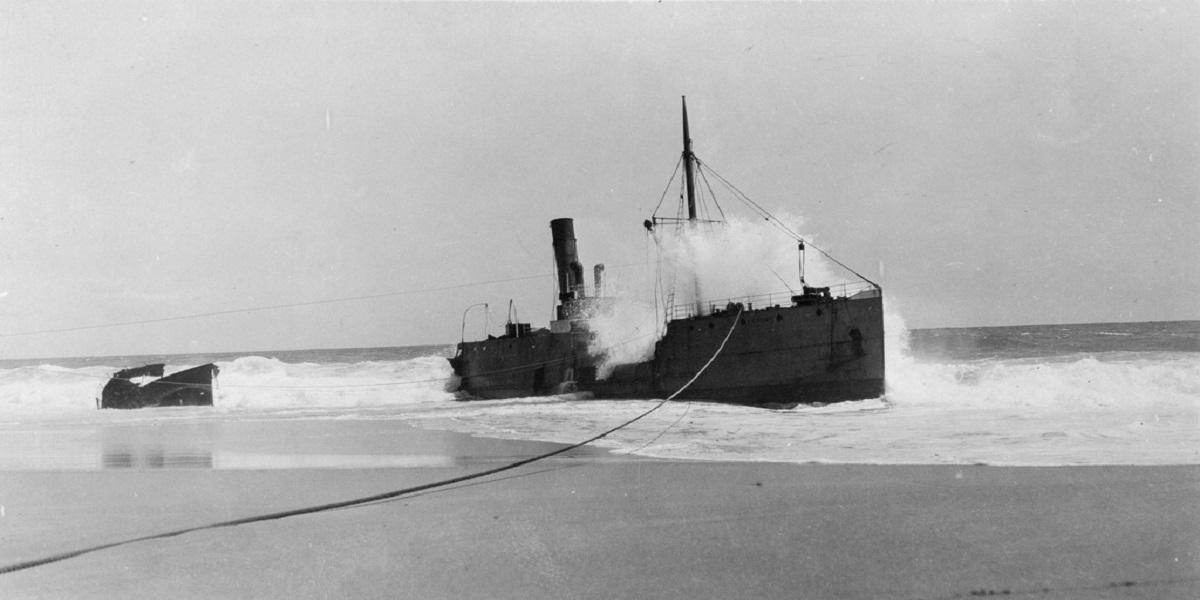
[408,353,1200,464]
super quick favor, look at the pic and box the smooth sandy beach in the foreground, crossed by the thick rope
[0,421,1200,599]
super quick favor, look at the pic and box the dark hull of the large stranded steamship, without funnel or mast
[451,294,884,407]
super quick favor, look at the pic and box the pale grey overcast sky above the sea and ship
[0,2,1200,358]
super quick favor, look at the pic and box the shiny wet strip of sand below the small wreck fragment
[0,414,595,472]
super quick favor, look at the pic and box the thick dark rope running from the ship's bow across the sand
[0,308,742,575]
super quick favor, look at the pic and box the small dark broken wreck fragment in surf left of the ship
[98,364,218,408]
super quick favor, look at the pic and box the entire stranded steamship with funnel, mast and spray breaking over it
[450,101,884,408]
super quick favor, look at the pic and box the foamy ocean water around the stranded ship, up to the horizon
[0,322,1200,468]
